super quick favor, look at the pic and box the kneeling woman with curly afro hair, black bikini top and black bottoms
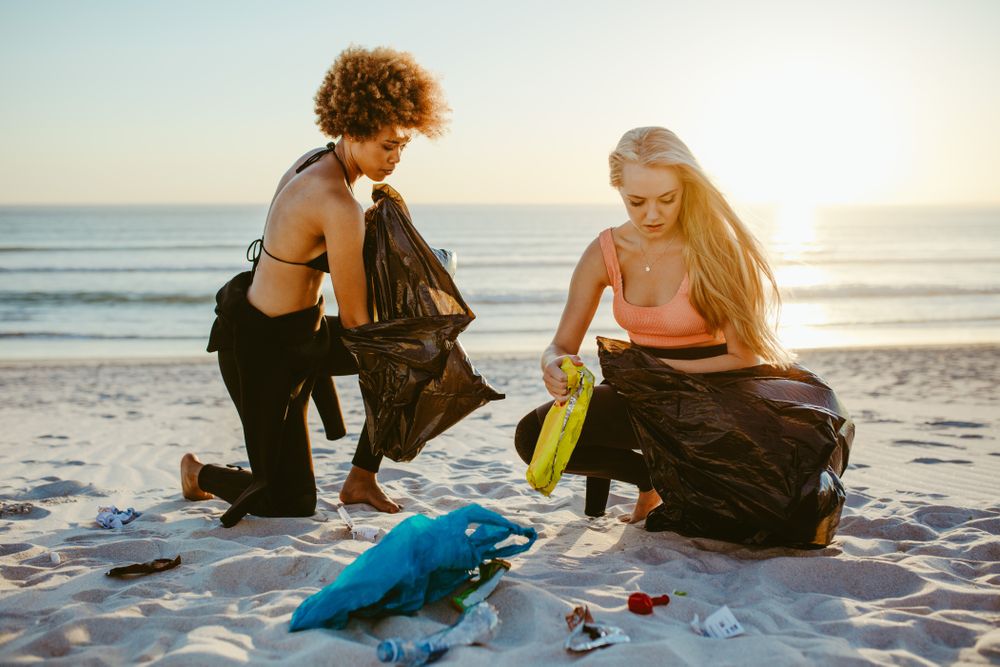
[181,47,449,526]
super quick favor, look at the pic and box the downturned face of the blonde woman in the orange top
[618,162,684,238]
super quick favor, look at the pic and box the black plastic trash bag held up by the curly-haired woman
[342,184,504,461]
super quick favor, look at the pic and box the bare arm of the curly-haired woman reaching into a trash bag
[322,198,371,329]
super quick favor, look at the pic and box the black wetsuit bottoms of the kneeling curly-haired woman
[198,273,381,526]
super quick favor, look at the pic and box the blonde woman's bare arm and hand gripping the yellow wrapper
[542,239,610,401]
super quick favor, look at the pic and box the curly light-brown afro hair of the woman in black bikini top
[313,46,451,140]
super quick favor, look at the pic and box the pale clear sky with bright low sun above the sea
[0,0,1000,205]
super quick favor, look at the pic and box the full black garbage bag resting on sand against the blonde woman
[598,338,854,548]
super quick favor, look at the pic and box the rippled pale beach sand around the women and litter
[0,346,1000,666]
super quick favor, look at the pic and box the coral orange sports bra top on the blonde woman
[598,228,726,347]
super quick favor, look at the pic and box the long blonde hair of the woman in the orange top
[608,127,794,368]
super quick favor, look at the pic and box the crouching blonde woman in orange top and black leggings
[515,127,792,522]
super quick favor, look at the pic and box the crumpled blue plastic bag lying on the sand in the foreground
[290,504,538,632]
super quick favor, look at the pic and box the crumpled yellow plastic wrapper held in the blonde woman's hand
[525,357,594,495]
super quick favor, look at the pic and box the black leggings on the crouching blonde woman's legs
[514,384,653,516]
